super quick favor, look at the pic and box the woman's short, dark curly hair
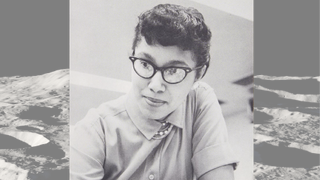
[132,4,211,77]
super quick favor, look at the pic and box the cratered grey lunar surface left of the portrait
[0,69,69,180]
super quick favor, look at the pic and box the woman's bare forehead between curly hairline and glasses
[135,38,196,68]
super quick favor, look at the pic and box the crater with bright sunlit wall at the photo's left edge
[0,130,50,149]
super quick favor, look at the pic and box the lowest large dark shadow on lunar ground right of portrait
[254,142,320,168]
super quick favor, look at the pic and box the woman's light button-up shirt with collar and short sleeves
[70,82,238,180]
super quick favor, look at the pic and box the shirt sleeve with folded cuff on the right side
[192,83,238,178]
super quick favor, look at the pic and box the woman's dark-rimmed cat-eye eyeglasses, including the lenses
[129,56,204,84]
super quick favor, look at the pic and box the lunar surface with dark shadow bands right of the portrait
[254,75,320,180]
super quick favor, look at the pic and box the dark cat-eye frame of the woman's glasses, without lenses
[129,56,206,84]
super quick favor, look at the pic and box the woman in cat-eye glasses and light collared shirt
[70,4,238,180]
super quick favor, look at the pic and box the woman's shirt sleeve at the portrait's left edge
[70,109,106,180]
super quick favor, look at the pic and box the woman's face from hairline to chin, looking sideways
[131,38,196,119]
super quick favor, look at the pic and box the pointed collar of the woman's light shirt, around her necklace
[125,95,185,140]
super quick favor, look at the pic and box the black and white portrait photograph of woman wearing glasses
[69,0,253,180]
